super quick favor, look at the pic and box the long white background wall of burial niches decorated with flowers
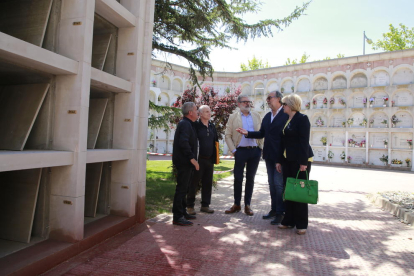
[147,50,414,170]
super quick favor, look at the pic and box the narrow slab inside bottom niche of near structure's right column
[85,163,103,218]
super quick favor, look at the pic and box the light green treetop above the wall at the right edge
[372,23,414,52]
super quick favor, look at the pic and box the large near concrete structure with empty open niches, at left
[0,0,155,275]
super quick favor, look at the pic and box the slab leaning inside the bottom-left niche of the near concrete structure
[0,169,42,243]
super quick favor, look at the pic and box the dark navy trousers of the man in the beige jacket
[234,148,262,206]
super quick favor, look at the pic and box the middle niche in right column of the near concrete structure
[87,90,115,149]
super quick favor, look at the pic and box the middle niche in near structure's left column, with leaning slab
[0,83,51,150]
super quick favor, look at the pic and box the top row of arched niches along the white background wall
[241,67,414,95]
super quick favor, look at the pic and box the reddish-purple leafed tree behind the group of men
[170,85,241,140]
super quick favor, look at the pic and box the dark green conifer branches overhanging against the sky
[152,0,310,84]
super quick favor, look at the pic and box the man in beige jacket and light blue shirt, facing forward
[225,95,263,216]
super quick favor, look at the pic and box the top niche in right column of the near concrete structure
[92,14,118,75]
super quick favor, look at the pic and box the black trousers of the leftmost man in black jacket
[172,166,195,220]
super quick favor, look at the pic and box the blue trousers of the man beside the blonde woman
[265,159,285,215]
